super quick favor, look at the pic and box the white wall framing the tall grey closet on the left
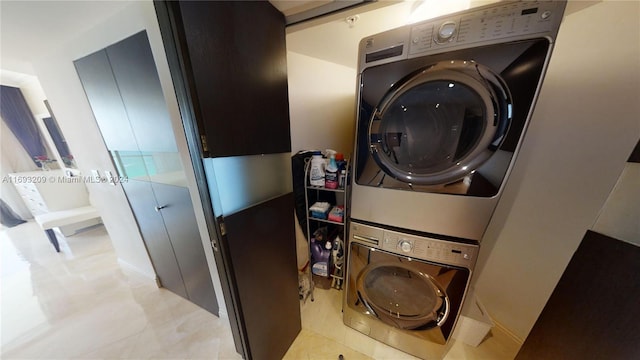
[28,1,226,316]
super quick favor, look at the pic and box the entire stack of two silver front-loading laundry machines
[343,1,566,359]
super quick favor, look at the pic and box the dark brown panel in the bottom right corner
[516,231,640,360]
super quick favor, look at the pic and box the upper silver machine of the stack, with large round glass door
[351,1,566,241]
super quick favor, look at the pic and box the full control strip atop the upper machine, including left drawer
[358,0,567,73]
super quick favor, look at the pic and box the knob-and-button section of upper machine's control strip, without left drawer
[409,1,565,55]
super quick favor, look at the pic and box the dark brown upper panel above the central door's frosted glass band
[179,1,291,157]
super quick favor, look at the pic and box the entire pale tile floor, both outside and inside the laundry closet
[0,222,519,360]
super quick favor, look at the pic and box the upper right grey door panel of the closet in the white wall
[107,31,178,152]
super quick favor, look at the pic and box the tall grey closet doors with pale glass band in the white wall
[74,31,218,315]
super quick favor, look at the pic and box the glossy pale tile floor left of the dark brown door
[0,222,241,359]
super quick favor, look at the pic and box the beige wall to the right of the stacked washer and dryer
[474,1,640,339]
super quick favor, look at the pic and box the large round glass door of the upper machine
[369,61,511,185]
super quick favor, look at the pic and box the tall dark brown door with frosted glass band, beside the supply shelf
[154,1,301,360]
